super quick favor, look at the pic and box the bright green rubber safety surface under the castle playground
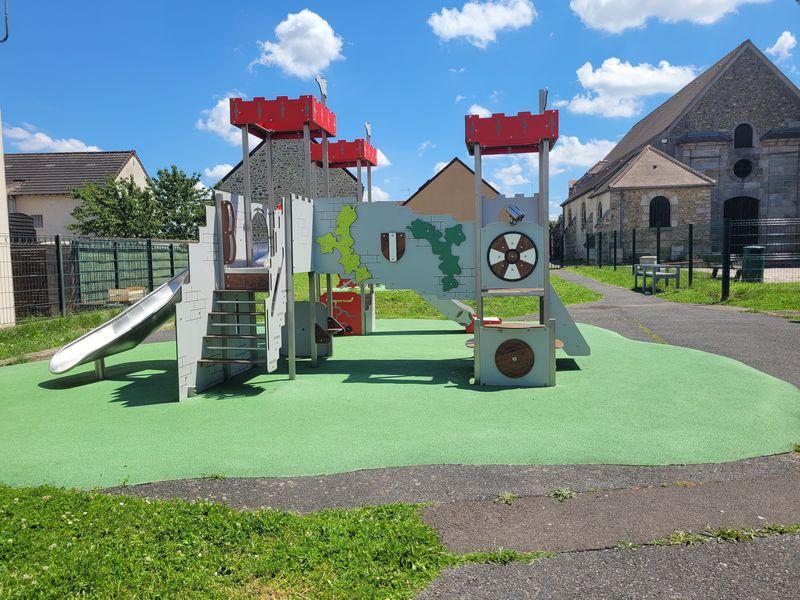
[0,320,800,487]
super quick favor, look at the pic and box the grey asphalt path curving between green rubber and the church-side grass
[558,270,800,386]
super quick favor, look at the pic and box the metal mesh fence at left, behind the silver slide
[0,235,189,319]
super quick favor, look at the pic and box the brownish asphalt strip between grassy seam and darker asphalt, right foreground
[423,474,800,554]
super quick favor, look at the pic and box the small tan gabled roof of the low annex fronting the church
[595,145,716,194]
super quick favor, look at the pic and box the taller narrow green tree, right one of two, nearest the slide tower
[150,165,208,240]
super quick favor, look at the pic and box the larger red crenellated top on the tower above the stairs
[230,96,336,139]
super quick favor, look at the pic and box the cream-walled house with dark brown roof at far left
[4,150,149,236]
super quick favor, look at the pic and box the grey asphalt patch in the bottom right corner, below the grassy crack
[418,535,800,600]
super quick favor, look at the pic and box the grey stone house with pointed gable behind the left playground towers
[217,140,358,203]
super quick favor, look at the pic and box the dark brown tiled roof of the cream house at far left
[5,150,144,195]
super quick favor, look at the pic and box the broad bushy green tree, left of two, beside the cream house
[69,177,163,238]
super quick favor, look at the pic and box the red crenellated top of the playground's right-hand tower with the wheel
[465,110,558,154]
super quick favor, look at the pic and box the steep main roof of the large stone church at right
[562,40,800,206]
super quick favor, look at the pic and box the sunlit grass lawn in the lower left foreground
[0,486,544,599]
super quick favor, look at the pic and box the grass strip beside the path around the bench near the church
[569,265,800,312]
